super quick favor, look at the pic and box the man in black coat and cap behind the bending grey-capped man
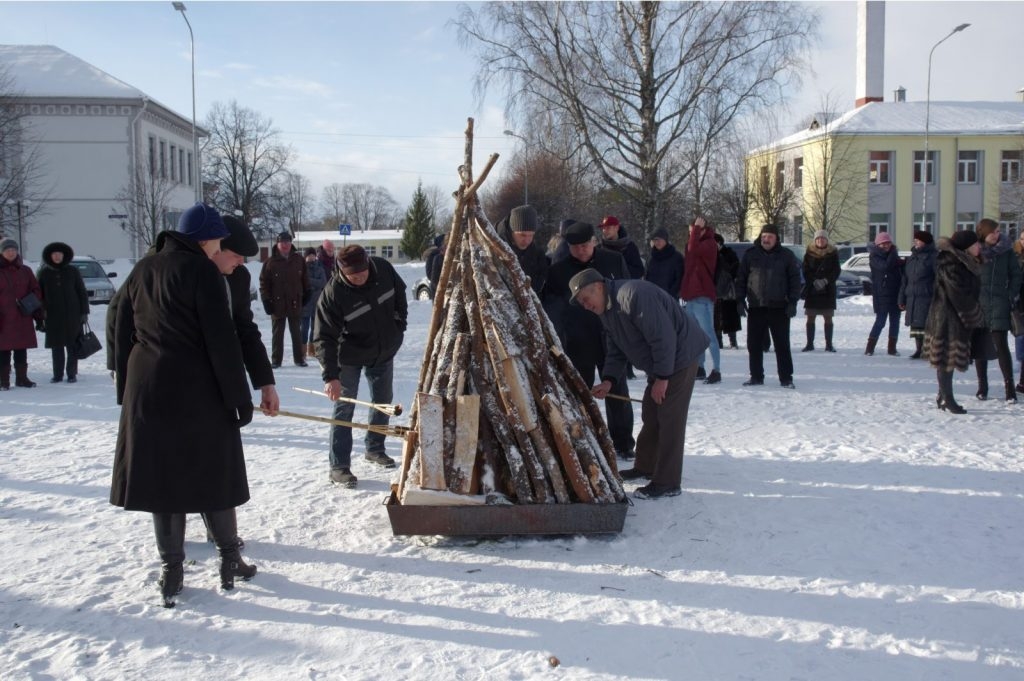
[541,222,636,460]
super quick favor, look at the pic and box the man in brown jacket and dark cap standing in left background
[259,231,311,369]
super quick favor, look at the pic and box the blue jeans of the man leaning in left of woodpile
[331,360,394,468]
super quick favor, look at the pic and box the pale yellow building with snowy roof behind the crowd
[745,101,1024,249]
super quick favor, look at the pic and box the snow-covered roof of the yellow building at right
[751,101,1024,154]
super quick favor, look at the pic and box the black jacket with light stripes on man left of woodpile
[313,256,409,374]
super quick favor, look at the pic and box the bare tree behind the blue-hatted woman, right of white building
[204,100,292,224]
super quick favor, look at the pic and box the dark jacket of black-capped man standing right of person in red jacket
[736,240,800,314]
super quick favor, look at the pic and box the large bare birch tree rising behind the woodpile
[457,2,817,238]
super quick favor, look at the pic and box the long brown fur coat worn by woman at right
[924,237,985,372]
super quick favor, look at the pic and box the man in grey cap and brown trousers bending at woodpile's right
[569,269,708,499]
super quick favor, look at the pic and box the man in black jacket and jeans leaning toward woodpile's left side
[313,244,409,487]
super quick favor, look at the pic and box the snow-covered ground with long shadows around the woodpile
[0,261,1024,681]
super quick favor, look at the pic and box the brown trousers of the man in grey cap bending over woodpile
[634,361,698,487]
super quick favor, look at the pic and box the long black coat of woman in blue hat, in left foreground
[111,231,253,513]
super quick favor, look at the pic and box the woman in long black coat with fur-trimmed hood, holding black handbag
[36,242,89,383]
